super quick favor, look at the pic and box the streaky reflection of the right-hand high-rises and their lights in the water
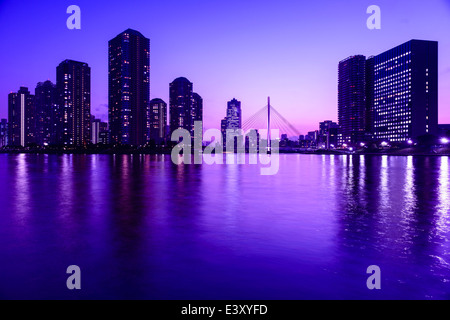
[330,156,450,298]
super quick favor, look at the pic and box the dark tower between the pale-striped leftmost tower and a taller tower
[34,80,61,145]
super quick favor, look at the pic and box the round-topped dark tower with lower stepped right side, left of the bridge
[169,77,203,137]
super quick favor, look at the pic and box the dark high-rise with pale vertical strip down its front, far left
[8,87,36,147]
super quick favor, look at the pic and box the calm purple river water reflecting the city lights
[0,154,450,299]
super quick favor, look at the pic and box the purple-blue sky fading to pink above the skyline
[0,0,450,133]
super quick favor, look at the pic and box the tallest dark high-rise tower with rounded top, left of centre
[108,29,150,146]
